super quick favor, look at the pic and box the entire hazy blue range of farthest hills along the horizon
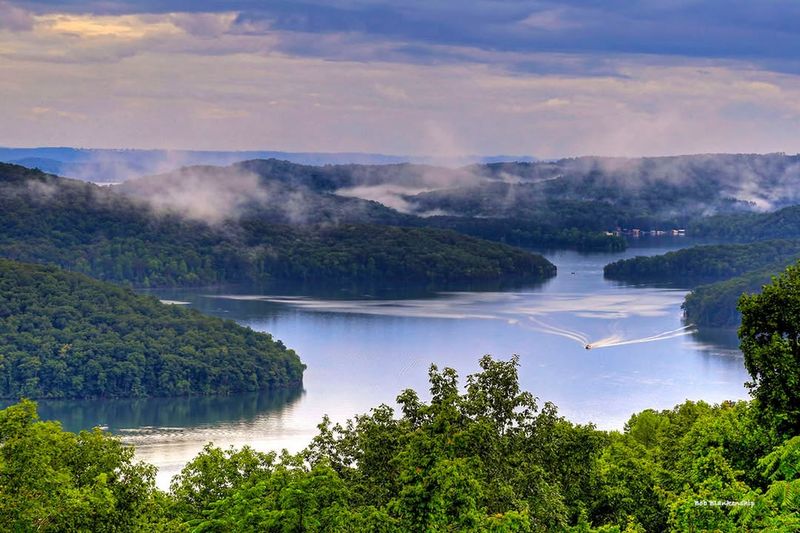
[7,153,800,237]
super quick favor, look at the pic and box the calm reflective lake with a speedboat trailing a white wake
[31,239,748,487]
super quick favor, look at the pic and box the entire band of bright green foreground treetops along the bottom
[0,356,800,533]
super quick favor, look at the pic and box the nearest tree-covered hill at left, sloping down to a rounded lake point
[0,260,305,398]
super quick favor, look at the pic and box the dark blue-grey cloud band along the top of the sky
[15,0,800,74]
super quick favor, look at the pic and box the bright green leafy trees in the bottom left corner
[0,401,168,531]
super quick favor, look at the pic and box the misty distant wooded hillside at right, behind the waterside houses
[406,154,800,229]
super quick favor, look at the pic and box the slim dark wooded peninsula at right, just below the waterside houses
[603,240,800,287]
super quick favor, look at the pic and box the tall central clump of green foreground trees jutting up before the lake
[167,357,603,531]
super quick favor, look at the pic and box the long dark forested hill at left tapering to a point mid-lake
[0,165,555,286]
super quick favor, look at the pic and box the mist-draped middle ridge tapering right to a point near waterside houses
[118,159,625,251]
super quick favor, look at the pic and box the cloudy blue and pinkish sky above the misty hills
[0,0,800,158]
